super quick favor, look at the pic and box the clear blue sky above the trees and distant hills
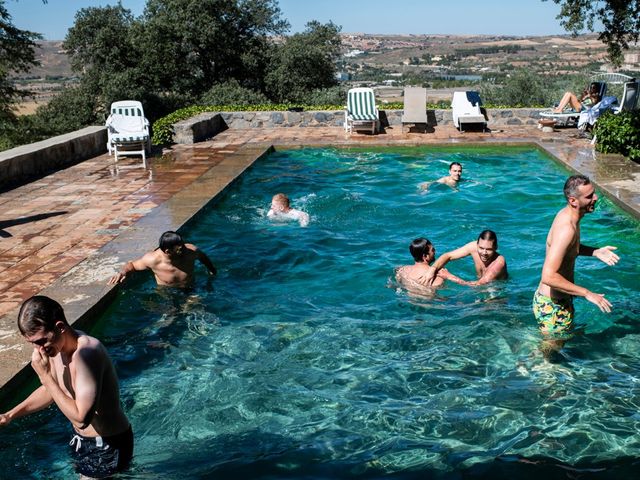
[5,0,566,40]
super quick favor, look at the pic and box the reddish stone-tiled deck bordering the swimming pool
[0,122,640,403]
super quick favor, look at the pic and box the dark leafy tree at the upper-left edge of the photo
[0,0,42,126]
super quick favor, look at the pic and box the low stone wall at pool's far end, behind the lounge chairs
[173,108,541,144]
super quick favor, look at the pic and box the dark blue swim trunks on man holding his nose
[69,426,133,478]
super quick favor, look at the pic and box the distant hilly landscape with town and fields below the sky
[10,33,640,113]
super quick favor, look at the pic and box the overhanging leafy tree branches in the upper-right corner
[543,0,640,66]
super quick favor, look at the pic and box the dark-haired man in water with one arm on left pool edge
[109,231,216,287]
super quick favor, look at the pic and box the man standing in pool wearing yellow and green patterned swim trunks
[533,175,619,352]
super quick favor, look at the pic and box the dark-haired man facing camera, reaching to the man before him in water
[424,230,509,287]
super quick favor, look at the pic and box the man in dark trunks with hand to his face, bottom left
[0,296,133,478]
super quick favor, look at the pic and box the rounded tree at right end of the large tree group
[265,21,342,102]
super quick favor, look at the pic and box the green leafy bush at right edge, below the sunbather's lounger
[593,110,640,161]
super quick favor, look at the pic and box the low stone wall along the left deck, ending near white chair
[0,126,107,190]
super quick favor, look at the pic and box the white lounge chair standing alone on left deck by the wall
[106,100,151,168]
